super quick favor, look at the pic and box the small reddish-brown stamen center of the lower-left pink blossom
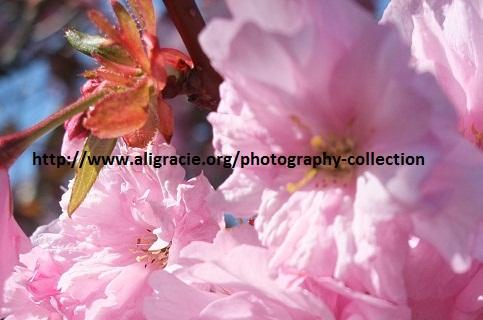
[134,229,171,269]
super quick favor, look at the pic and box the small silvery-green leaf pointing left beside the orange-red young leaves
[65,29,133,65]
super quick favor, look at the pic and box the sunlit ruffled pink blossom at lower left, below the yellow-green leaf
[1,138,219,320]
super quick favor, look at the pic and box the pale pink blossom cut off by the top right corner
[382,0,483,148]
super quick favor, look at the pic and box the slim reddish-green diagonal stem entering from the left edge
[0,90,107,169]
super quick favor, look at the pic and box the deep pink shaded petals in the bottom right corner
[403,238,483,320]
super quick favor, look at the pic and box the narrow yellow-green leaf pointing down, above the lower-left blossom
[67,135,117,216]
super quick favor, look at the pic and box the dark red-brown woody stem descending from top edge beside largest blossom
[163,0,223,111]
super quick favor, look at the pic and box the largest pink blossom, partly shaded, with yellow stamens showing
[200,1,483,310]
